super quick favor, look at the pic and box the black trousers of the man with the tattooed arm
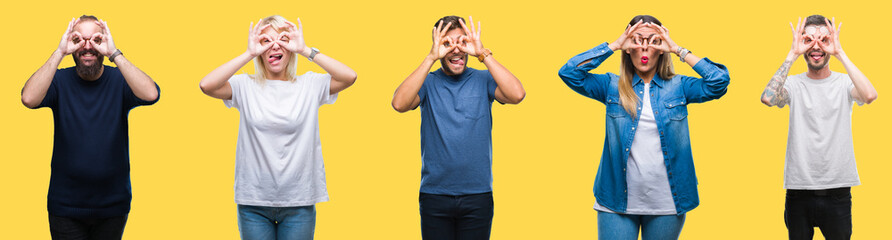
[784,187,852,240]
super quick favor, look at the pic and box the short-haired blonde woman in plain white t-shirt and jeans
[200,16,356,239]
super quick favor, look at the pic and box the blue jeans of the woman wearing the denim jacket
[598,211,685,240]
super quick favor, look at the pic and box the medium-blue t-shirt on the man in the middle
[418,68,497,195]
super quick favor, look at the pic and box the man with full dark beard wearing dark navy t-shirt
[22,15,160,239]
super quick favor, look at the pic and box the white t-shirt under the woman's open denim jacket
[594,83,677,215]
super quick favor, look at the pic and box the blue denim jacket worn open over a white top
[558,43,730,215]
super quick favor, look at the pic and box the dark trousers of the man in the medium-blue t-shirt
[418,192,494,240]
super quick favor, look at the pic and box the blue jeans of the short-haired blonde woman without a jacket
[238,205,316,240]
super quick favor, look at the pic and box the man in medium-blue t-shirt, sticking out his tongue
[392,16,526,239]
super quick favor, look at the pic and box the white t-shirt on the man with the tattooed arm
[784,72,863,190]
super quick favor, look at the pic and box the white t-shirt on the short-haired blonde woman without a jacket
[223,72,337,207]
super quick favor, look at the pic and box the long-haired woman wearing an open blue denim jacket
[559,15,729,240]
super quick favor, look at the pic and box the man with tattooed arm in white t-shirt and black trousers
[762,15,877,239]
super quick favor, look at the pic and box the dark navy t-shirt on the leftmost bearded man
[37,66,160,218]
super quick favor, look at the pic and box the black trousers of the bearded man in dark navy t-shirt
[50,215,127,240]
